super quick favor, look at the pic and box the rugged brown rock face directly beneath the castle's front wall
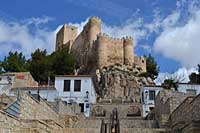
[97,65,154,102]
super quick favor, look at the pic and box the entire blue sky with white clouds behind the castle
[0,0,200,81]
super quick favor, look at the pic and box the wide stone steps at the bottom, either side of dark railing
[54,118,169,133]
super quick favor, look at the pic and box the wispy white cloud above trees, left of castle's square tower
[0,17,56,57]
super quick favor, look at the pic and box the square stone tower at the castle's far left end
[56,24,78,51]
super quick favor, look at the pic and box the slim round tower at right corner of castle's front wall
[123,37,134,66]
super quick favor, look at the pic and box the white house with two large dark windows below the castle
[55,75,96,117]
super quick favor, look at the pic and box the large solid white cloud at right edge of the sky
[154,10,200,68]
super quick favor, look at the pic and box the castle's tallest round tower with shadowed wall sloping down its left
[71,18,101,67]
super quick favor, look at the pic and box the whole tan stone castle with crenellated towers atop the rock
[56,17,146,73]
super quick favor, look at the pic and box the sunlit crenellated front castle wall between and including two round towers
[94,34,134,69]
